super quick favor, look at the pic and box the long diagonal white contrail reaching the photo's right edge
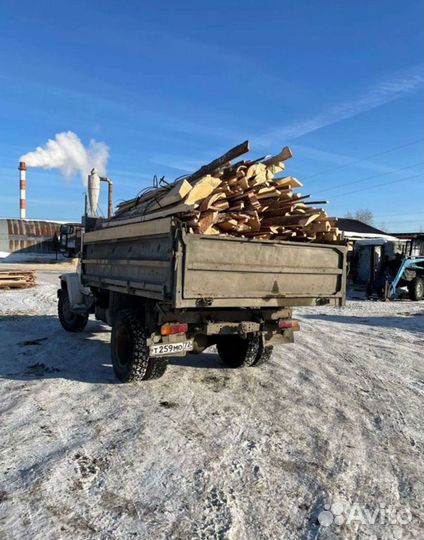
[254,64,424,146]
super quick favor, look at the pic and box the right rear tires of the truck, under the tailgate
[216,335,259,368]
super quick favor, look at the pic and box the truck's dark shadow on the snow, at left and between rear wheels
[0,315,226,384]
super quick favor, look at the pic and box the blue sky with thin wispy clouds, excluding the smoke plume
[0,0,424,232]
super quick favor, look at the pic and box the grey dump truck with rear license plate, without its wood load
[58,216,347,382]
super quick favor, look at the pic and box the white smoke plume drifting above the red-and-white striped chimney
[20,131,109,183]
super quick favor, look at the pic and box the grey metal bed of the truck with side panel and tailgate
[82,218,346,308]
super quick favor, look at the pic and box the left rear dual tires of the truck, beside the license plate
[111,309,168,382]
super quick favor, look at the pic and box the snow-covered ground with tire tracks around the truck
[0,265,424,540]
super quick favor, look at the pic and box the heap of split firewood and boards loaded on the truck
[113,141,341,243]
